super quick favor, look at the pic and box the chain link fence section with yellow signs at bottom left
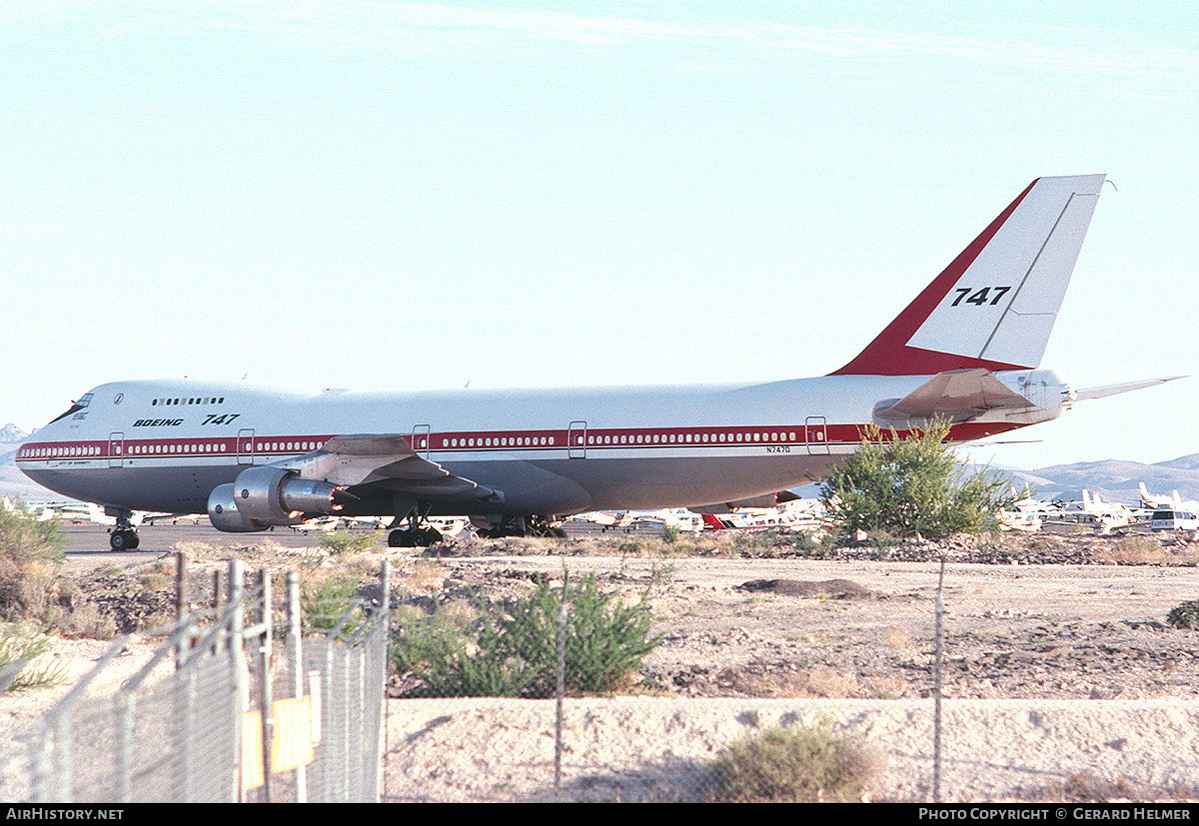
[22,553,388,803]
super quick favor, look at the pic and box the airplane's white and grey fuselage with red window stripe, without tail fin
[17,370,1067,516]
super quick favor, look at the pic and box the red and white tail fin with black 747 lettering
[832,175,1104,375]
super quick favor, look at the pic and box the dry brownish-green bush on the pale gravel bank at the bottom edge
[711,724,878,803]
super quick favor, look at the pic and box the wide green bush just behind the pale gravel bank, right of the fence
[392,574,661,697]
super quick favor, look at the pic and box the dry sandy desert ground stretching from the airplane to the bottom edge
[0,527,1199,801]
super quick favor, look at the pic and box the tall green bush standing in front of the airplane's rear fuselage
[820,422,1023,538]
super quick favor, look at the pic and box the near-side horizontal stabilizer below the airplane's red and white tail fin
[874,367,1035,424]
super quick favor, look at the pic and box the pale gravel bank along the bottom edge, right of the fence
[385,698,1199,802]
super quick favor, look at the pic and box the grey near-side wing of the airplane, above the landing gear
[279,433,502,502]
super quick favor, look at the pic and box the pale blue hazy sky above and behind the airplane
[0,0,1199,469]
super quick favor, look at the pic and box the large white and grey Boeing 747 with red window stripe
[17,175,1179,548]
